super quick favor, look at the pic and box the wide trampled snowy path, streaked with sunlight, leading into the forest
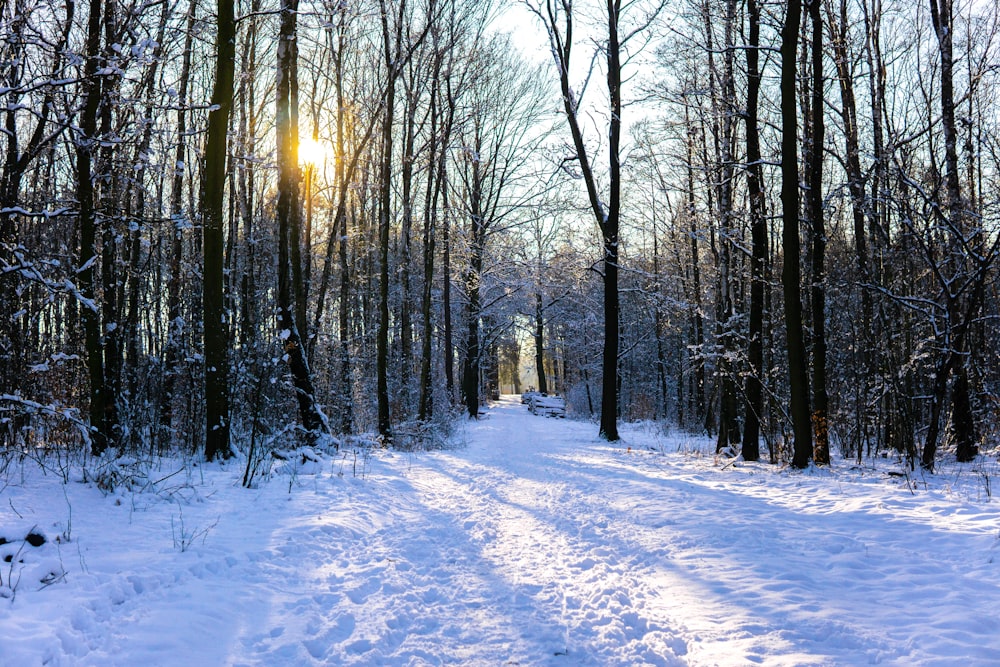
[225,397,1000,665]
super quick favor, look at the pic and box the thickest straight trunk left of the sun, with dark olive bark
[201,0,236,461]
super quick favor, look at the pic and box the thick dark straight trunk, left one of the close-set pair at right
[781,0,812,468]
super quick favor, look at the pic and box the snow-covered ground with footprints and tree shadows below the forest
[0,397,1000,666]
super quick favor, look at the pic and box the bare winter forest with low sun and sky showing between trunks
[0,0,1000,471]
